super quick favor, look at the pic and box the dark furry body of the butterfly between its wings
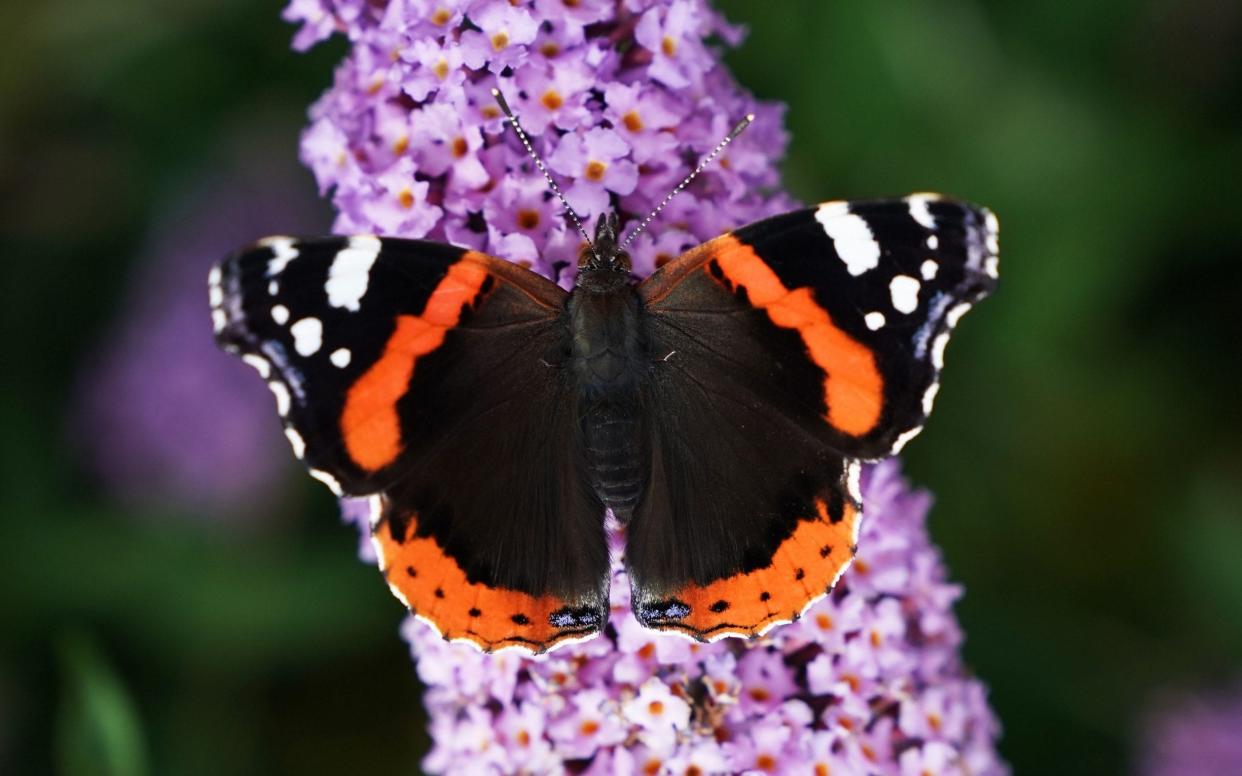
[568,274,650,521]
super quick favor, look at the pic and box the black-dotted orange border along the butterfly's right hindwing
[652,500,858,639]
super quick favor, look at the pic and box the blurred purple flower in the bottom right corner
[1140,684,1242,776]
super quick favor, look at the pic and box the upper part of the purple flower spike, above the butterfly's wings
[286,0,792,283]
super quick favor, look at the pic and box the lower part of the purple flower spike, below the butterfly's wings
[404,461,1006,776]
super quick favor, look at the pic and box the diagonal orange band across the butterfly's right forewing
[712,235,884,436]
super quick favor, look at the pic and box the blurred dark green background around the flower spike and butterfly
[0,0,1242,775]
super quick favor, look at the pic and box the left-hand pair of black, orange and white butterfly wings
[211,237,609,652]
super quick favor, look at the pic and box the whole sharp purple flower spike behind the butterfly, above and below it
[295,0,1005,775]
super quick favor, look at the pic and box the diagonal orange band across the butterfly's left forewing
[340,253,487,472]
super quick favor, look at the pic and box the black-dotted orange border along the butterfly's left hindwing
[374,518,597,652]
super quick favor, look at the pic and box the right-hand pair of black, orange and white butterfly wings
[627,195,996,638]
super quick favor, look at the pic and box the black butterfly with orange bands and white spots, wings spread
[210,98,997,652]
